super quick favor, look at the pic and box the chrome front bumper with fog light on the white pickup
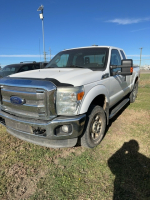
[0,111,86,148]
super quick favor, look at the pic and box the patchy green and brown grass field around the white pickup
[0,74,150,200]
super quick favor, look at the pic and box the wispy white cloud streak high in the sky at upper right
[106,17,150,25]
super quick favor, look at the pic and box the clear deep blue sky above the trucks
[0,0,150,67]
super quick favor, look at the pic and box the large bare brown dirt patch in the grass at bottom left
[5,163,48,200]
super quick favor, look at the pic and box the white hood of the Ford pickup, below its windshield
[9,68,104,86]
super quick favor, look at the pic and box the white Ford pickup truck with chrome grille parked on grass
[0,46,139,148]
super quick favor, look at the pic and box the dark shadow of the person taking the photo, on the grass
[108,140,150,200]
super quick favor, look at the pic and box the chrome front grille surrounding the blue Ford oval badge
[1,77,56,120]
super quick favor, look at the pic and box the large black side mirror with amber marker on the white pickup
[110,59,133,76]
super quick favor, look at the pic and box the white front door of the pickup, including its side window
[109,49,127,107]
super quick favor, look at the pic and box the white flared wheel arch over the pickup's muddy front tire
[79,85,109,114]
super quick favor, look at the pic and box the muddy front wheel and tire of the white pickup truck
[81,105,106,148]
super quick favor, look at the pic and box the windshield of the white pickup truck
[46,47,108,70]
